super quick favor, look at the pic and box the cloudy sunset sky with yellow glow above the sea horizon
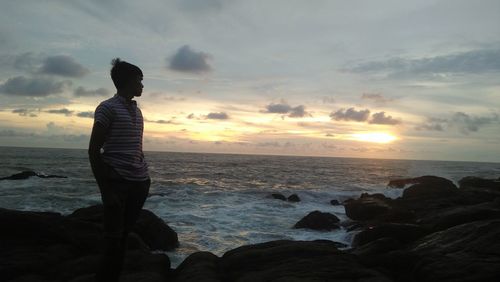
[0,0,500,162]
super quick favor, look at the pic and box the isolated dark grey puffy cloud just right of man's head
[169,45,212,73]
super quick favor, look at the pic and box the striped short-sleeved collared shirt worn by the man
[94,94,149,181]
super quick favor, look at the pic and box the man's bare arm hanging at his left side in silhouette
[89,122,109,186]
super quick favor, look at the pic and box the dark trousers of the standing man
[96,175,151,282]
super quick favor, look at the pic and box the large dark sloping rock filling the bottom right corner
[410,219,500,281]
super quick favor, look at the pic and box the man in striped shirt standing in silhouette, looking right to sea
[89,58,151,282]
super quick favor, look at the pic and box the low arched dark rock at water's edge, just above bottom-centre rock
[353,223,429,246]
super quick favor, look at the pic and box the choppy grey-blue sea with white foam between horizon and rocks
[0,147,500,267]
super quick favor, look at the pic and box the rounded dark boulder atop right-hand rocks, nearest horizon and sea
[403,176,458,199]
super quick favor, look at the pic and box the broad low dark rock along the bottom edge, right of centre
[174,241,391,282]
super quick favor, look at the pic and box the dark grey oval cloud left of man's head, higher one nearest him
[38,55,89,77]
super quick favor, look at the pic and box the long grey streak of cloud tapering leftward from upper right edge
[343,49,500,77]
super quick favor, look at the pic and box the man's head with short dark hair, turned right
[111,58,143,98]
